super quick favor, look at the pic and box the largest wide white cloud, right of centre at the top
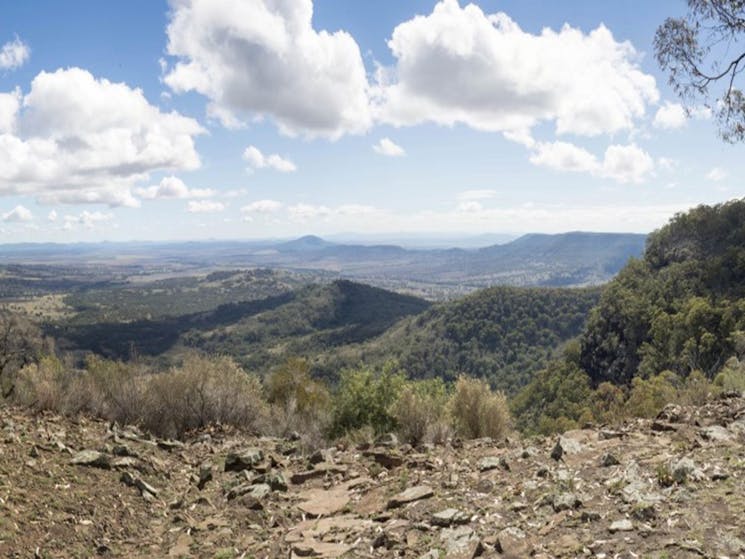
[377,0,659,138]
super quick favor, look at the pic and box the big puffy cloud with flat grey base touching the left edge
[0,68,204,206]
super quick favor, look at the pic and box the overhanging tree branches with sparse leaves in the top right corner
[654,0,745,143]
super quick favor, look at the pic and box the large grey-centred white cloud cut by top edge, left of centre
[164,0,371,138]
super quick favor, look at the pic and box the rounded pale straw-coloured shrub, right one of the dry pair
[450,376,511,439]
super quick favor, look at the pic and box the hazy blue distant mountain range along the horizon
[0,232,646,294]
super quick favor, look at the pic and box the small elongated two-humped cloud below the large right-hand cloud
[530,142,654,183]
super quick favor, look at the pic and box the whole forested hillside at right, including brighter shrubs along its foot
[513,200,745,432]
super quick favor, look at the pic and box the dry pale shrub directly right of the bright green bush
[392,379,448,446]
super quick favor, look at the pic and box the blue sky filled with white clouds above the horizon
[0,0,745,243]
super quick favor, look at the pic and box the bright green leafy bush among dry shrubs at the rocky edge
[331,364,406,436]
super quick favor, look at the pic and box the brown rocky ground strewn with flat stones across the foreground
[0,395,745,559]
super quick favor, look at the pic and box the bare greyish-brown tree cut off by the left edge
[0,310,42,398]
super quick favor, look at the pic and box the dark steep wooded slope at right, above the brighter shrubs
[580,200,745,386]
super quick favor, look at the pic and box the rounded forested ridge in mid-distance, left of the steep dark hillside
[362,287,599,393]
